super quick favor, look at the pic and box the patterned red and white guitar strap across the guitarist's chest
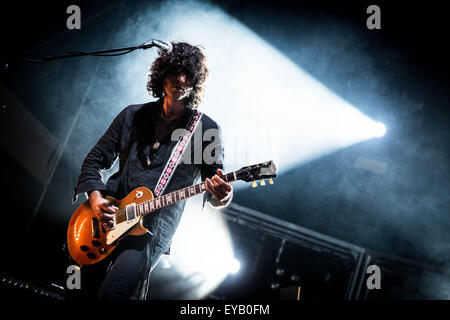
[154,109,203,197]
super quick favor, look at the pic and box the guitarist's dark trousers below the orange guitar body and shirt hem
[98,233,163,300]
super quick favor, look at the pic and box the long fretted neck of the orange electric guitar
[136,172,237,216]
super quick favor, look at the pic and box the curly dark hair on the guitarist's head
[147,42,209,109]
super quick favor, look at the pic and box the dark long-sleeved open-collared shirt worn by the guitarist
[73,99,223,252]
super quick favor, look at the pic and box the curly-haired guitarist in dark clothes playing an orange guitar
[73,42,233,300]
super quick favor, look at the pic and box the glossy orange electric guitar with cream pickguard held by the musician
[67,161,277,265]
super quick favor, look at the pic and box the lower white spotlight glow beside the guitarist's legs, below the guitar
[167,197,234,299]
